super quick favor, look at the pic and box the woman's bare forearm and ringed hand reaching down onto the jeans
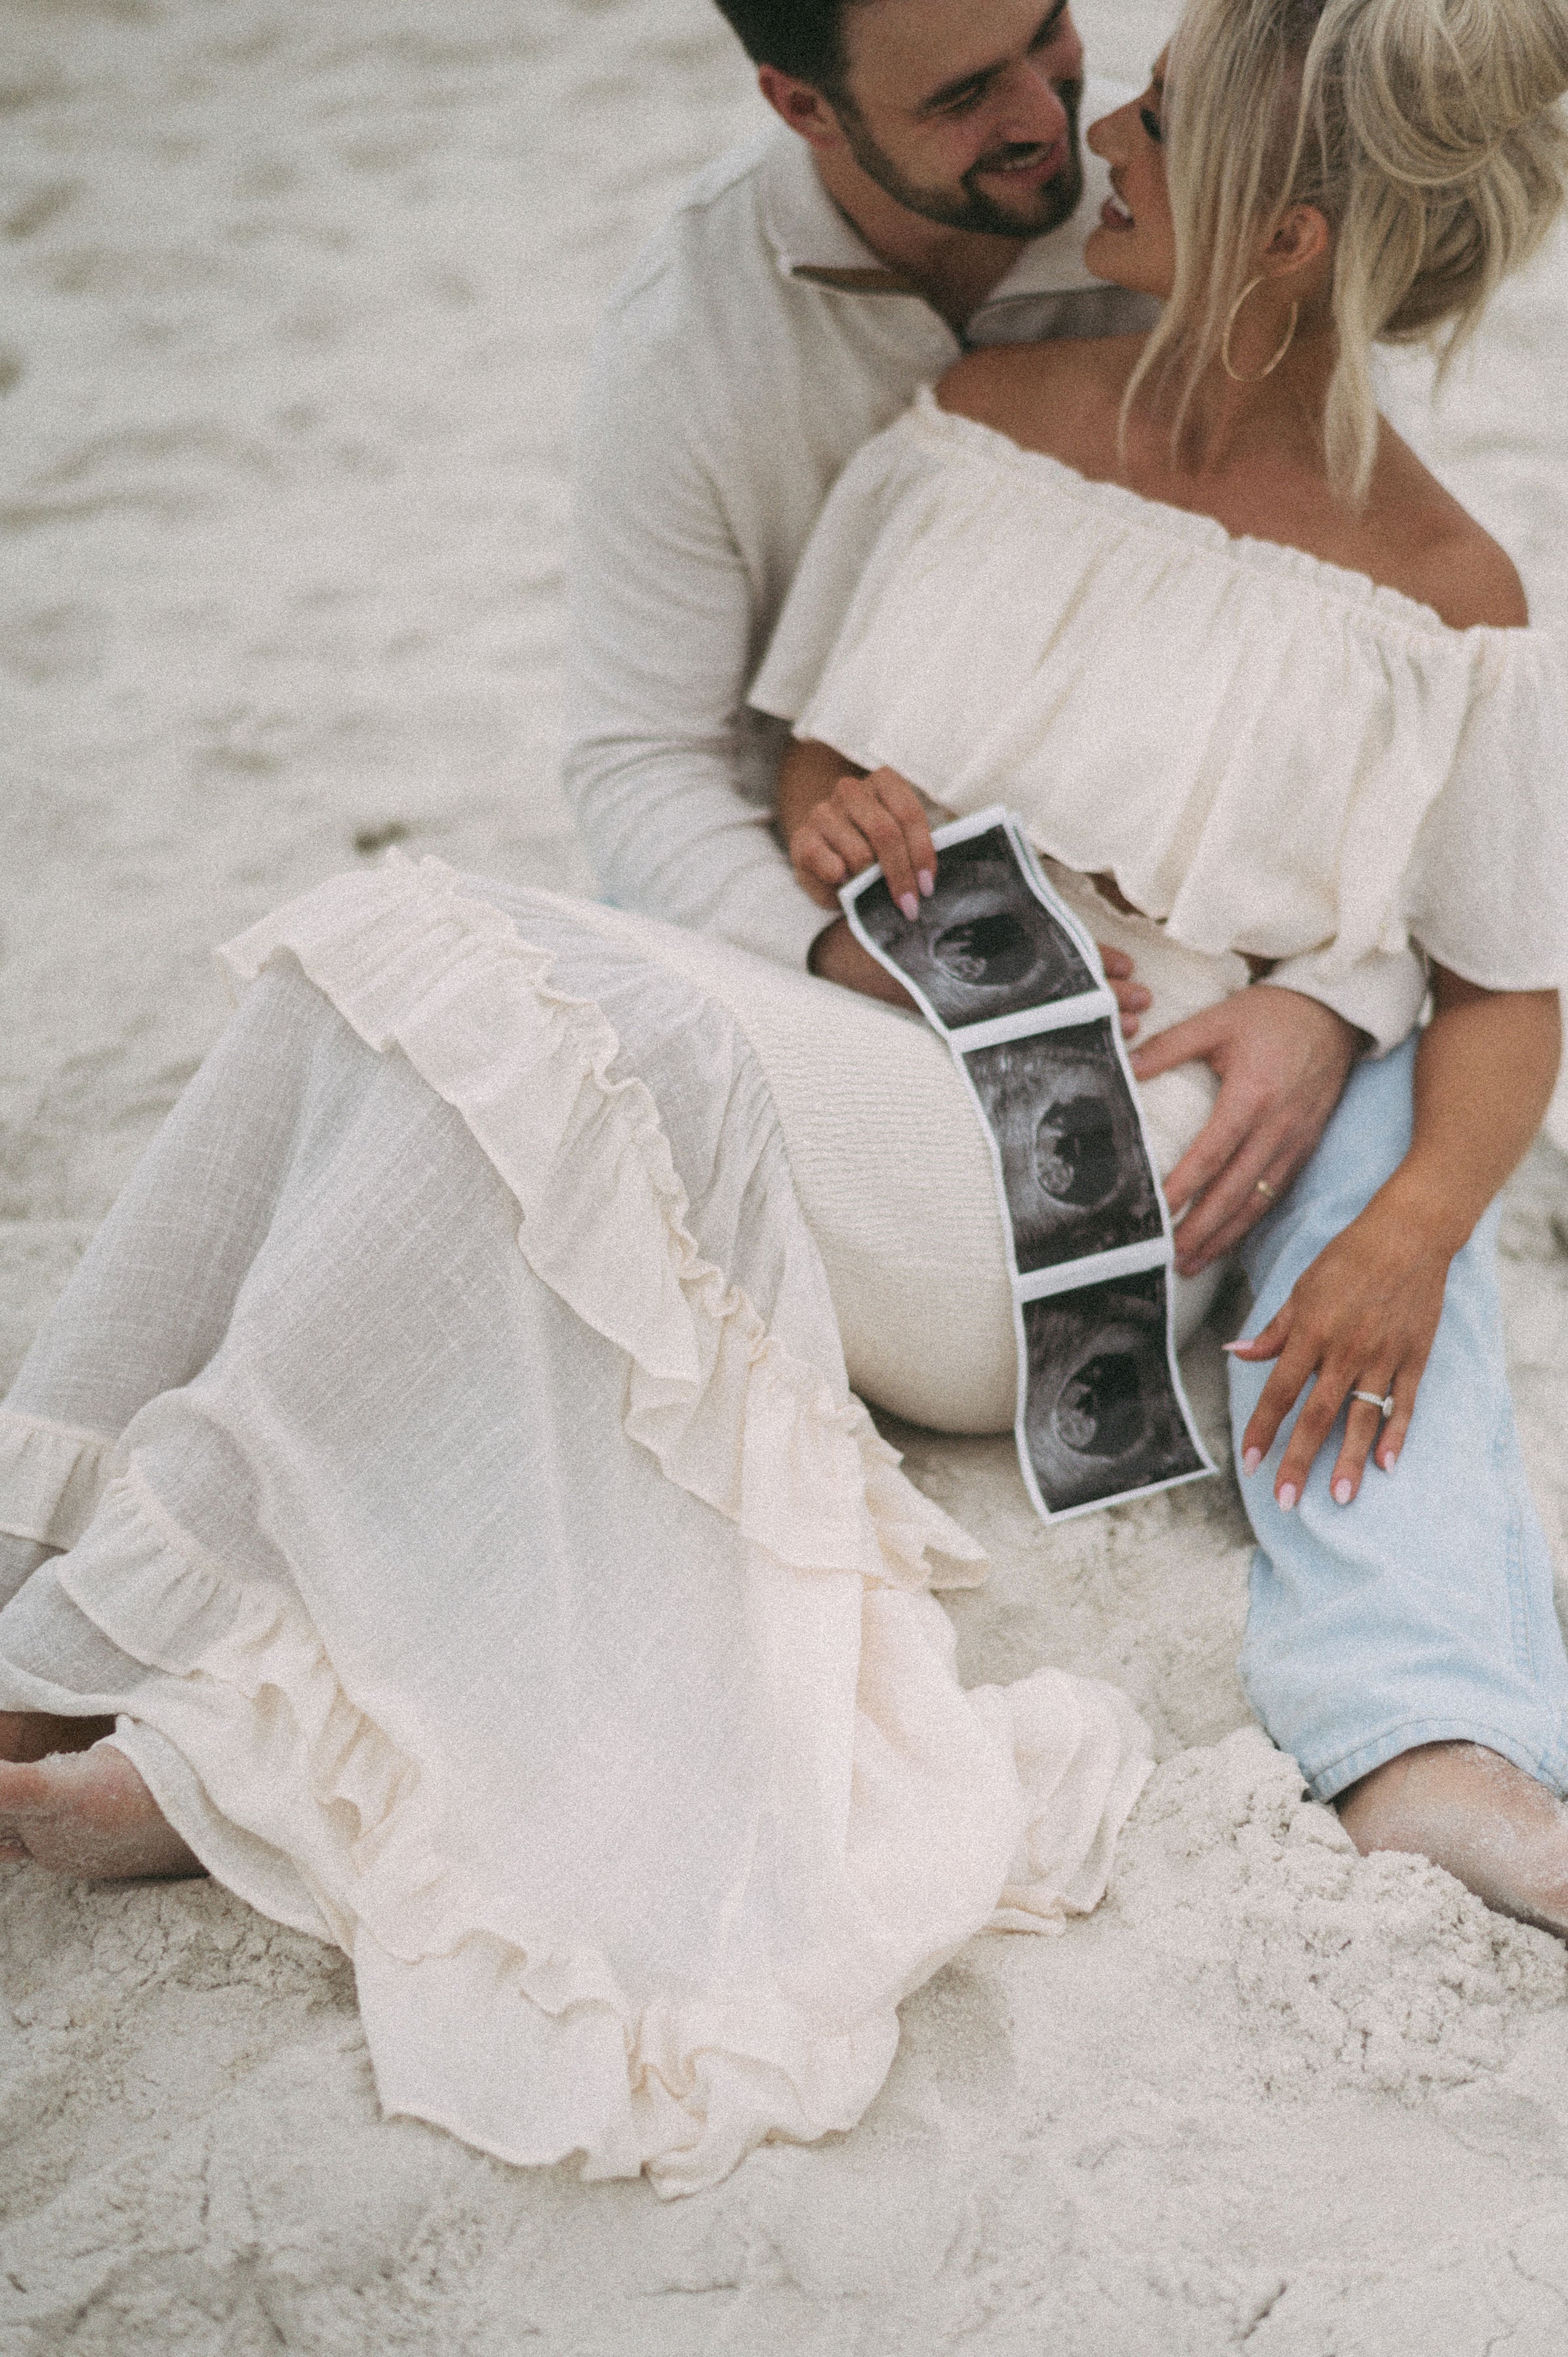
[1228,966,1561,1508]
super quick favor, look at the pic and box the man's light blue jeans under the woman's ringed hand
[1231,1042,1568,1800]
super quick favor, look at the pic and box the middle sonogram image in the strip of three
[964,1021,1165,1275]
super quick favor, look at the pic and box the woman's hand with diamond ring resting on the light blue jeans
[1226,1186,1453,1513]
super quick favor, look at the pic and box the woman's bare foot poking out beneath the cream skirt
[0,1753,205,1876]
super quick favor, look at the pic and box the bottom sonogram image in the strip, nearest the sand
[1023,1268,1207,1513]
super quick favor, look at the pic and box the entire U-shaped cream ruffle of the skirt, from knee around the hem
[0,863,1148,2195]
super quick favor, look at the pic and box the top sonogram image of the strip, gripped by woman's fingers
[856,828,1099,1030]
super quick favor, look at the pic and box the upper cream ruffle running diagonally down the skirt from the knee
[219,853,985,1588]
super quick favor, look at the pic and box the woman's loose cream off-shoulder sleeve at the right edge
[1403,629,1568,990]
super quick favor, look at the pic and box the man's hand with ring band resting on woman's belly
[1132,983,1360,1277]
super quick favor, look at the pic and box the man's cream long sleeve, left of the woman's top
[564,301,830,966]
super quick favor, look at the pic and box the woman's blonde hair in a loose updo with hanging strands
[1125,0,1568,504]
